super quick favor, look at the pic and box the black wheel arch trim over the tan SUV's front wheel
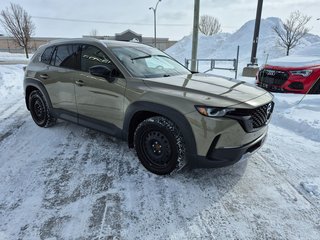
[123,101,197,158]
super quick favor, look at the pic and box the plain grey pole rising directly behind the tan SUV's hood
[191,0,200,72]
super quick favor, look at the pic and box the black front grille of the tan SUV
[227,102,274,132]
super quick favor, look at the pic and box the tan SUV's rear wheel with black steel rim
[29,90,56,127]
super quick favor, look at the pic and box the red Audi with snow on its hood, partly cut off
[256,64,320,94]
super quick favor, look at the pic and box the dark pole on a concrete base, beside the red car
[242,0,263,77]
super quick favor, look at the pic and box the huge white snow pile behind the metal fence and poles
[166,17,320,64]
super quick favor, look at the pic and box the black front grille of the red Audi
[259,69,289,86]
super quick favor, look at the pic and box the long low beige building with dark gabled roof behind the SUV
[0,29,176,53]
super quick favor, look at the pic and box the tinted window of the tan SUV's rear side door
[51,44,80,69]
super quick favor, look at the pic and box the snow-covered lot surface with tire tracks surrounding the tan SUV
[0,40,320,240]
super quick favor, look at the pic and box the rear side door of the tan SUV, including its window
[44,44,80,121]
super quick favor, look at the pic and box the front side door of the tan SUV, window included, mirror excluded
[75,45,126,134]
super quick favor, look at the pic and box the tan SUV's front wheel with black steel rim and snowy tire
[134,116,185,175]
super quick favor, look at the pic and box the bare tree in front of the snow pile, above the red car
[273,11,311,56]
